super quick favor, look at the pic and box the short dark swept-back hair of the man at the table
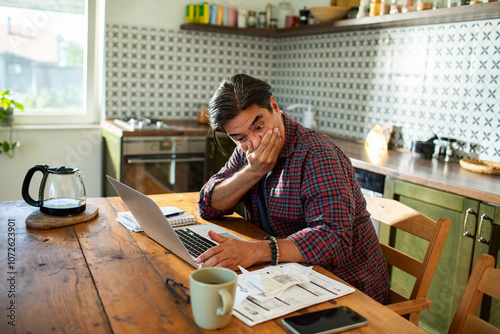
[208,74,273,155]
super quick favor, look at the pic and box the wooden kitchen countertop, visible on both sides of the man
[101,119,500,205]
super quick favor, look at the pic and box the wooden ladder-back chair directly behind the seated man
[366,196,451,326]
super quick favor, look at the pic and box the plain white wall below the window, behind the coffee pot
[0,126,102,201]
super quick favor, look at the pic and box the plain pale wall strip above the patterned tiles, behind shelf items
[106,0,330,29]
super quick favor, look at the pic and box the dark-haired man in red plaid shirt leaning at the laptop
[196,74,389,303]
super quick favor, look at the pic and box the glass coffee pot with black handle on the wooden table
[22,165,87,216]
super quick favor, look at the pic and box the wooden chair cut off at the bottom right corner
[448,254,500,334]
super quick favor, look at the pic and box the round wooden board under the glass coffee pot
[26,204,99,230]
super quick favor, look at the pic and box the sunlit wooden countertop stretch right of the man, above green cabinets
[330,134,500,205]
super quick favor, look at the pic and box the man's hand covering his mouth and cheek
[246,128,283,176]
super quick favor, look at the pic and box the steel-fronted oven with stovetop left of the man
[105,118,209,196]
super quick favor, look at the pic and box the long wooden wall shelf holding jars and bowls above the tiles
[181,1,500,38]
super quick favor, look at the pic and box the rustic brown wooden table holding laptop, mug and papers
[0,193,424,334]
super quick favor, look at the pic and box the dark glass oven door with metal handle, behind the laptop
[123,153,205,195]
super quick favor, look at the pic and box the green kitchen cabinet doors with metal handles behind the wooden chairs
[381,178,500,333]
